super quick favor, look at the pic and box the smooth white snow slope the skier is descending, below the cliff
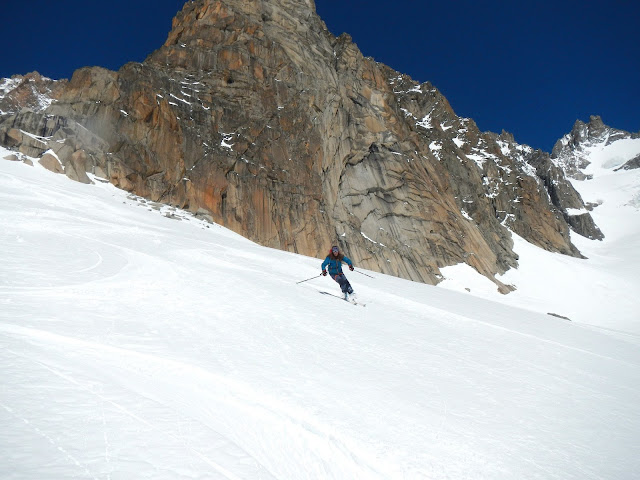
[0,155,640,480]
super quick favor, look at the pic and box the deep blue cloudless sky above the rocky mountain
[0,0,640,151]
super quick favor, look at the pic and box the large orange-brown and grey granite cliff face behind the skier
[0,0,601,292]
